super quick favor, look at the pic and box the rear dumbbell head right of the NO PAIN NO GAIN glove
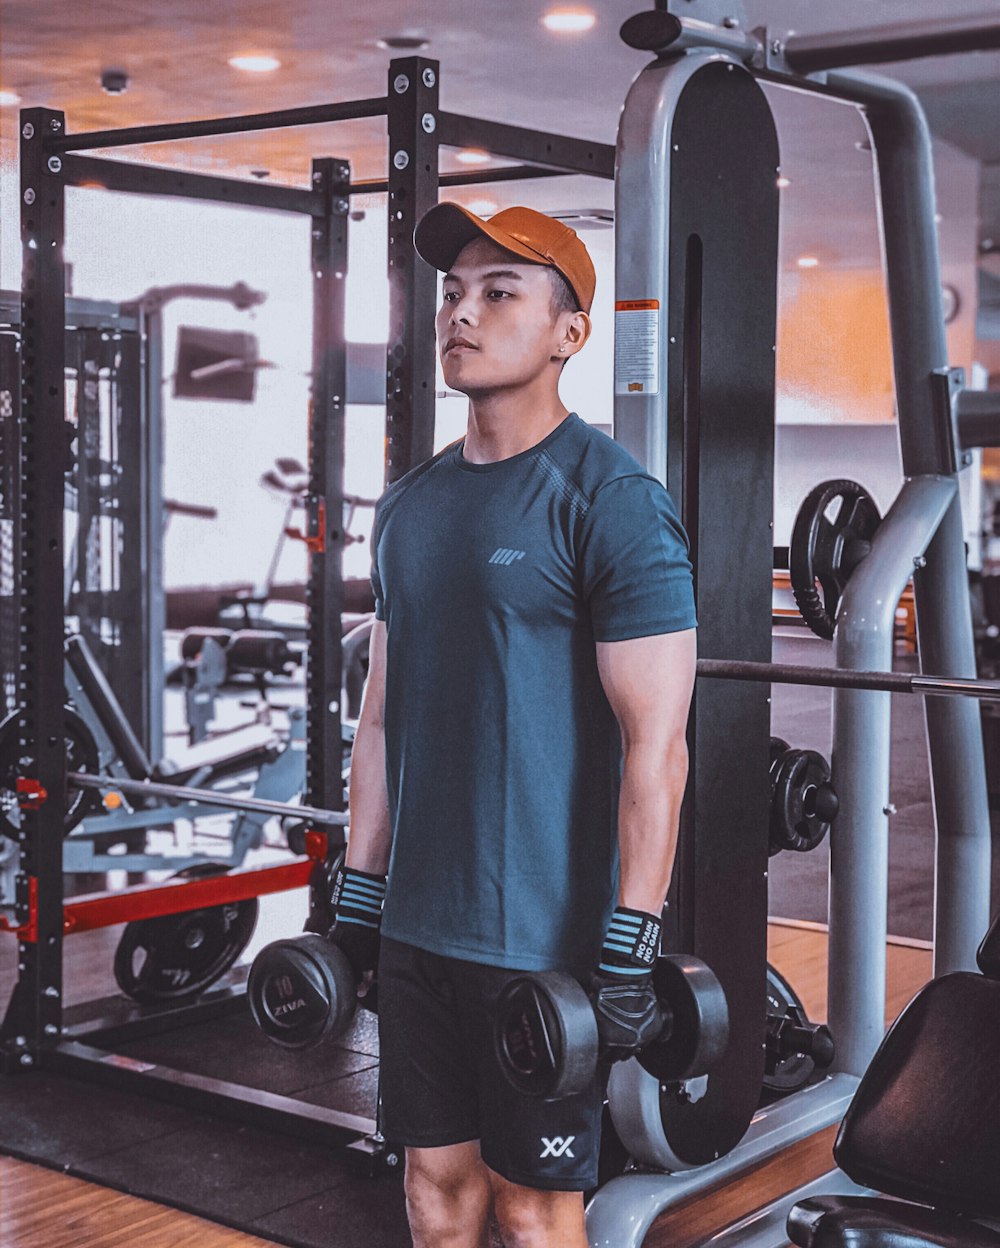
[639,953,729,1083]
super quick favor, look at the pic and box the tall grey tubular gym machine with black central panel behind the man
[588,0,1000,1248]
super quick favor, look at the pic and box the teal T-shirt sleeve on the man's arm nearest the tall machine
[579,474,697,641]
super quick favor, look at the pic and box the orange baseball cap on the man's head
[413,201,597,312]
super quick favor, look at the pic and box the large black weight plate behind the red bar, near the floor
[114,862,258,1005]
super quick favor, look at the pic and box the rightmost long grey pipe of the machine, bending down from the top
[828,72,990,975]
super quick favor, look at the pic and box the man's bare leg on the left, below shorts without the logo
[404,1139,489,1248]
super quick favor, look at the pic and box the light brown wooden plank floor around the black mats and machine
[0,922,931,1248]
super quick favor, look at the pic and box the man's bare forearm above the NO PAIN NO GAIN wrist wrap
[618,741,688,915]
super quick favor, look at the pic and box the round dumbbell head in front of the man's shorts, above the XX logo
[494,971,598,1099]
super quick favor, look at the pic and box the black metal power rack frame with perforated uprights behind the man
[0,56,614,1143]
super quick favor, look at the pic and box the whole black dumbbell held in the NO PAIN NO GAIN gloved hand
[493,953,729,1101]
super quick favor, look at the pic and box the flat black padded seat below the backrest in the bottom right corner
[788,1196,1000,1248]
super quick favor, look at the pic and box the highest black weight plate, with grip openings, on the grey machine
[788,480,881,640]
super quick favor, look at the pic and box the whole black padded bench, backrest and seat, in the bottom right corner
[788,914,1000,1248]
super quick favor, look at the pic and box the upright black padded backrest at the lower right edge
[834,973,1000,1218]
